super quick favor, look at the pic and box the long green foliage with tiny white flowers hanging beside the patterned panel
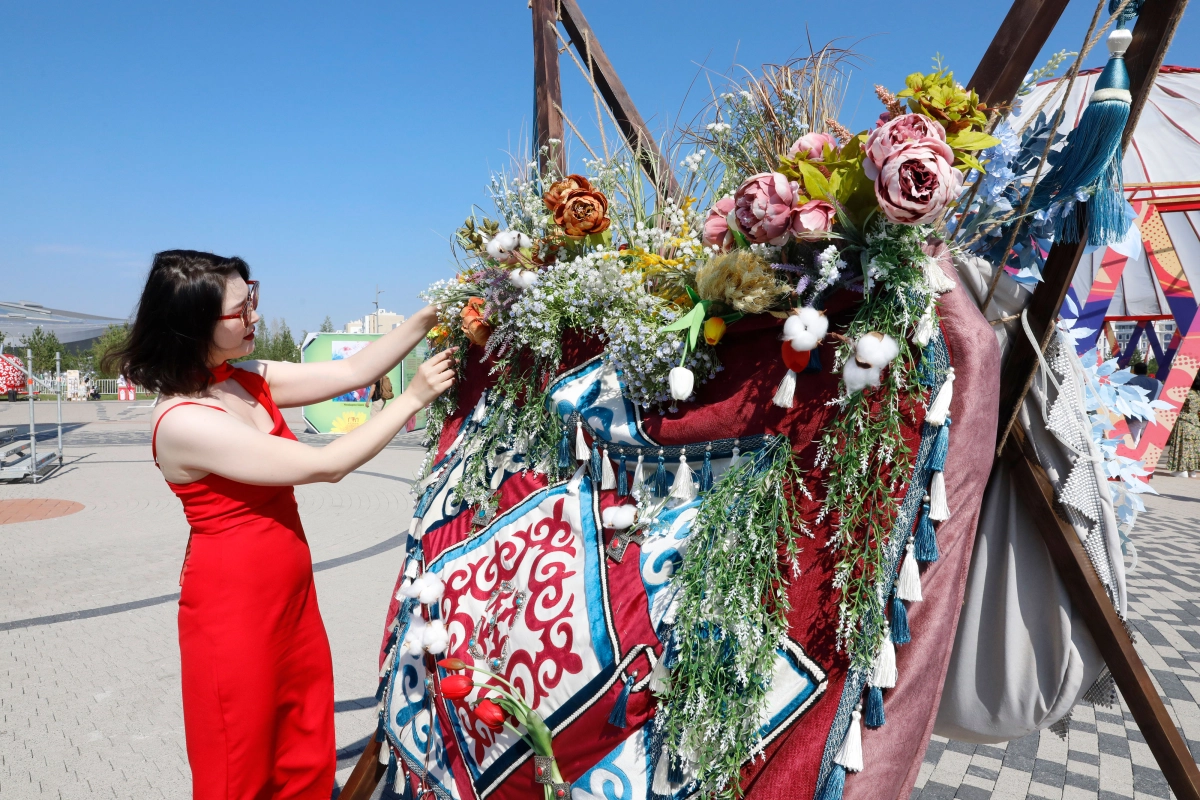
[659,438,808,798]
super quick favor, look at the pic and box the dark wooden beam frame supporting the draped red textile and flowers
[341,0,1200,800]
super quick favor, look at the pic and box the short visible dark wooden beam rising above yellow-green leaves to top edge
[967,0,1067,107]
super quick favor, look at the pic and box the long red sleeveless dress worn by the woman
[151,368,336,800]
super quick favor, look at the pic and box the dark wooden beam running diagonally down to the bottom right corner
[1002,426,1200,800]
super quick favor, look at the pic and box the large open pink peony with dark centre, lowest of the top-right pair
[875,139,962,225]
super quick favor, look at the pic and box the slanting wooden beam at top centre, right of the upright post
[556,0,679,197]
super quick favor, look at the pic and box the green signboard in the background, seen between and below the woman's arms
[300,333,425,433]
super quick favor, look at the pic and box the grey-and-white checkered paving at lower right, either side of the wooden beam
[911,477,1200,800]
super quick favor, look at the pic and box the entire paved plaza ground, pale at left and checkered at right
[0,402,1200,800]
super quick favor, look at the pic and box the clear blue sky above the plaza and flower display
[0,0,1200,335]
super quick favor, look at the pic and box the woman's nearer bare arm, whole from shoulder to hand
[157,350,455,486]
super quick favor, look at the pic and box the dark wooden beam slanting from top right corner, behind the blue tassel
[996,0,1188,455]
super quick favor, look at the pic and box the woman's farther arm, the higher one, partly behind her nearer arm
[238,306,438,408]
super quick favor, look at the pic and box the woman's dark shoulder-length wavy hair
[103,249,250,395]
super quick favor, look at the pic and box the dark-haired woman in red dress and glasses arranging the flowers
[110,251,454,800]
